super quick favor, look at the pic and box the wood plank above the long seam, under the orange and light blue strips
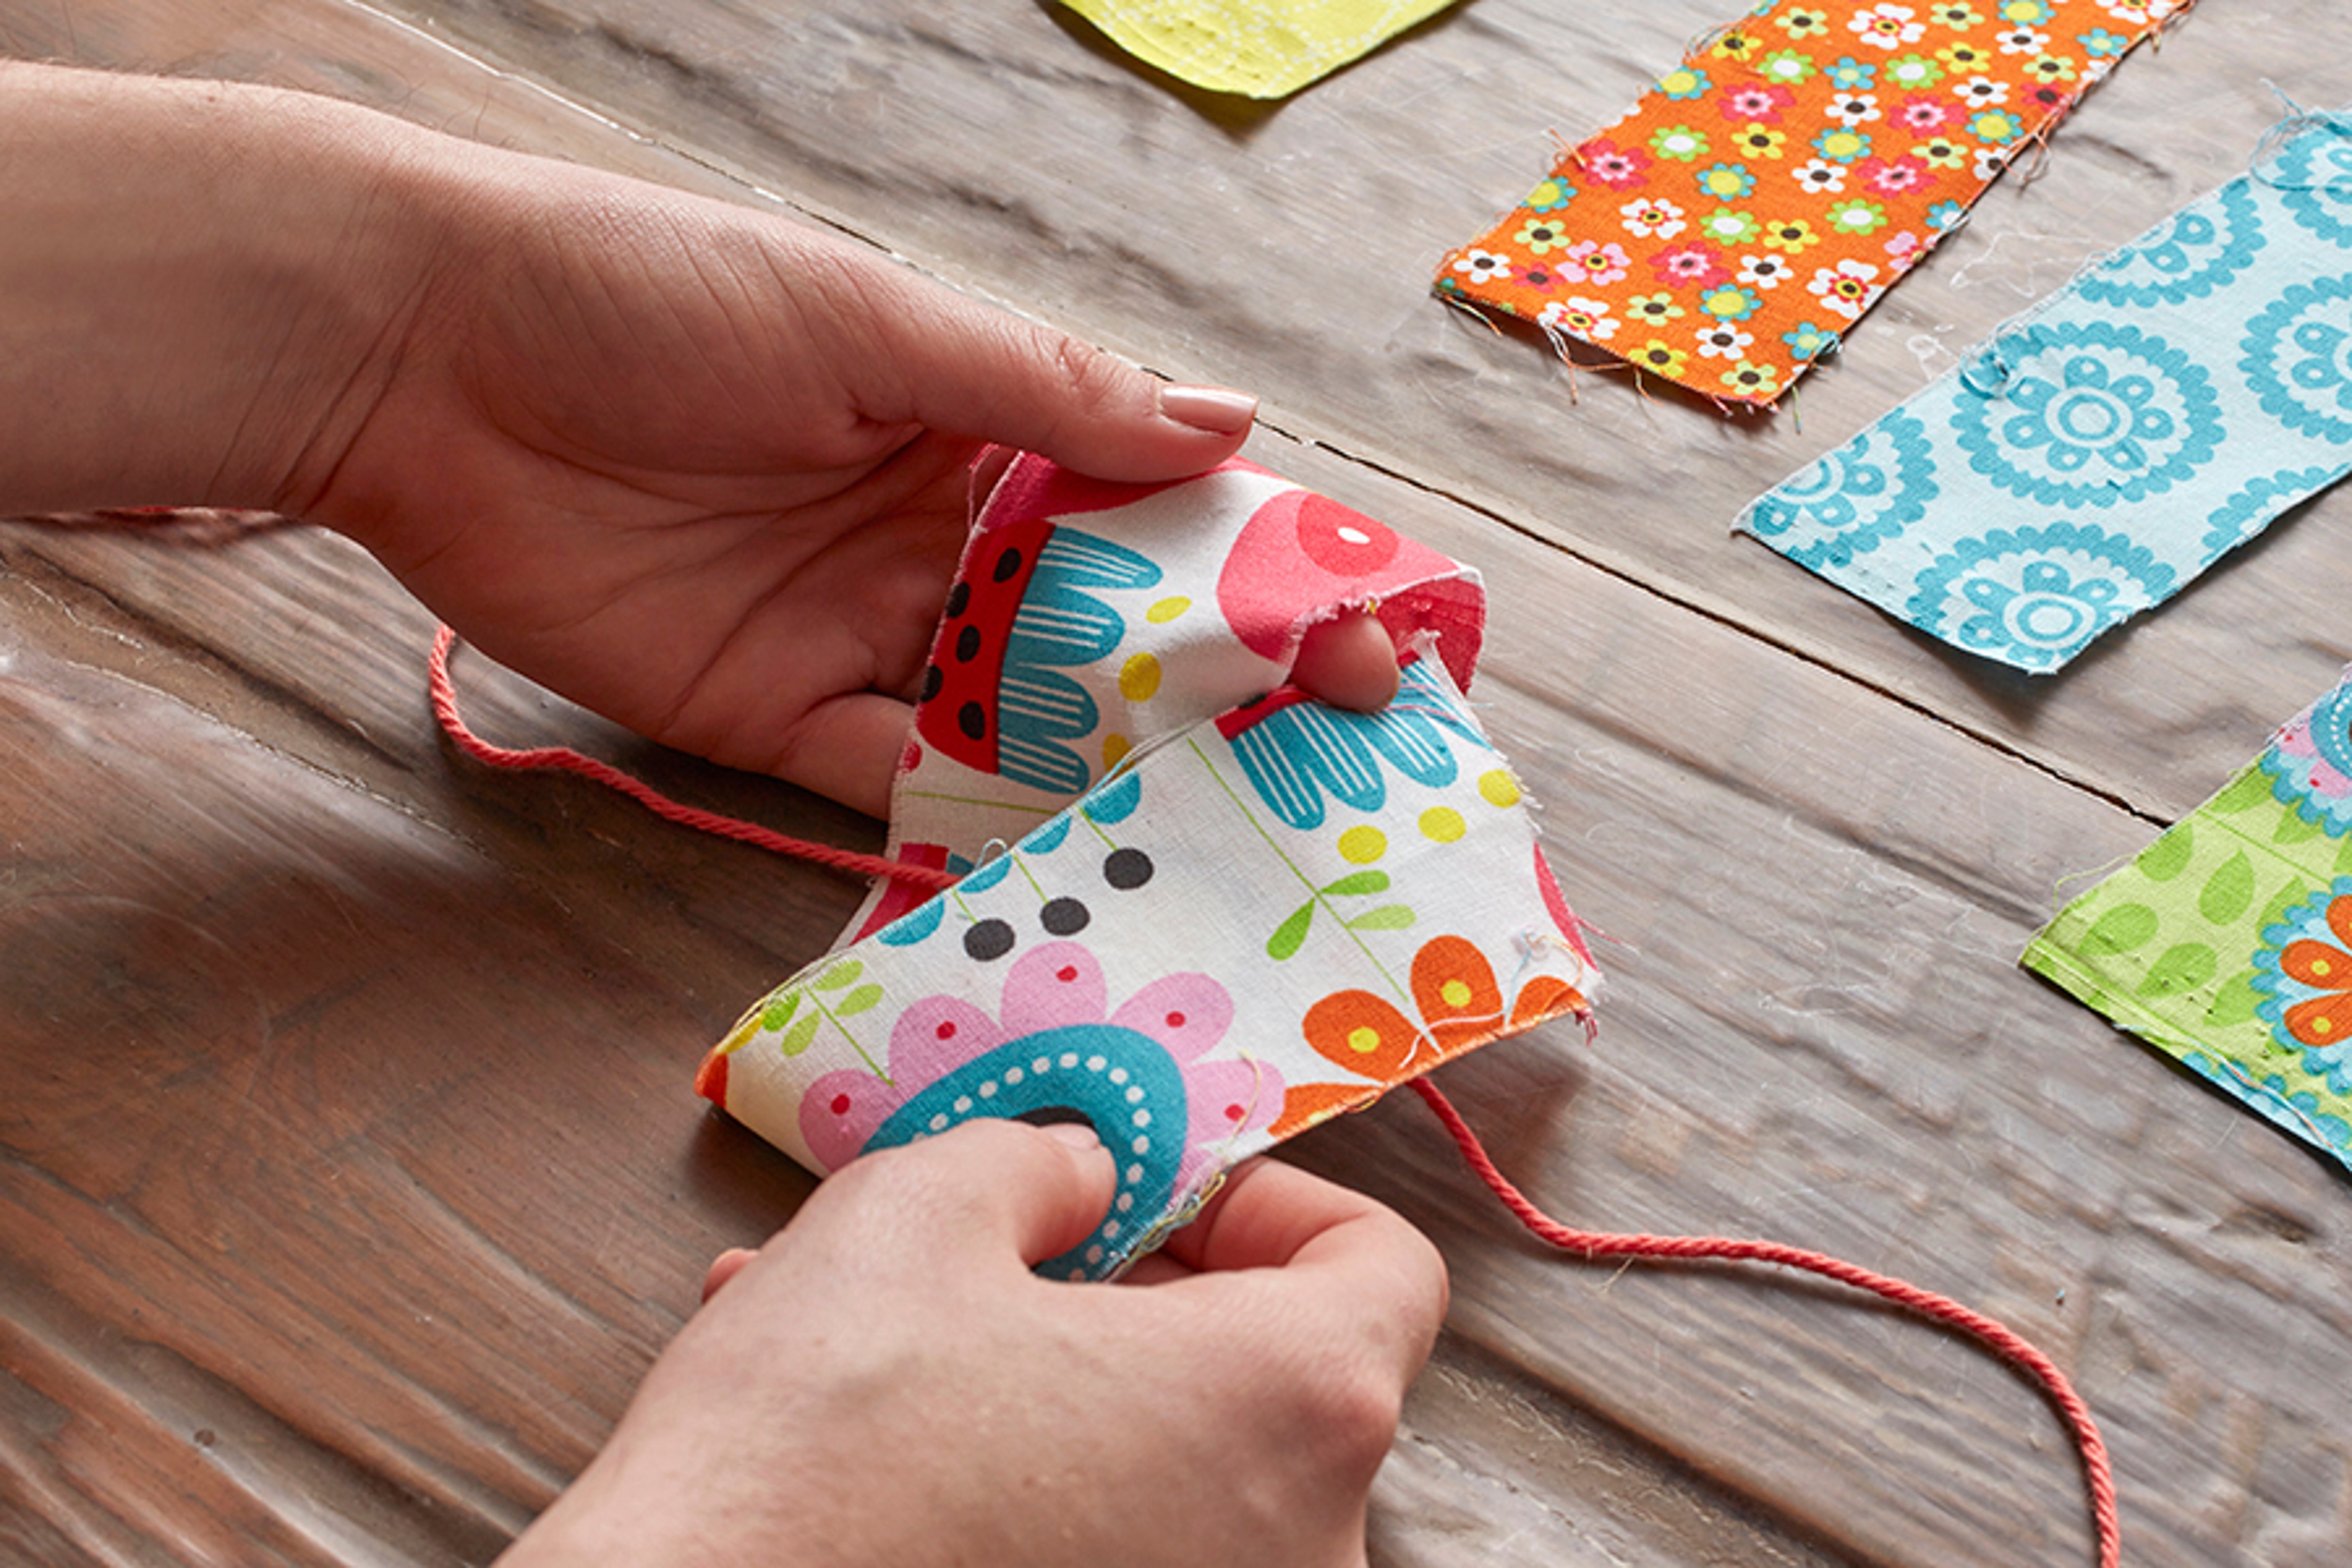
[326,0,2352,816]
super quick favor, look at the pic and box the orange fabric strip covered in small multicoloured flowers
[1437,0,2192,404]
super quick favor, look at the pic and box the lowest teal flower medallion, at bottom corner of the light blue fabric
[1903,522,2173,670]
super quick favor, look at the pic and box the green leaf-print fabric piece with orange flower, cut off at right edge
[2021,670,2352,1166]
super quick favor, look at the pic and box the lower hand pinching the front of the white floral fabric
[503,1121,1447,1568]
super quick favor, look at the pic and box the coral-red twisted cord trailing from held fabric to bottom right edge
[1414,1079,2124,1568]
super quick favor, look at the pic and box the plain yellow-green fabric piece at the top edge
[1063,0,1453,99]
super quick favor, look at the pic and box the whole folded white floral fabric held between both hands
[696,456,1599,1279]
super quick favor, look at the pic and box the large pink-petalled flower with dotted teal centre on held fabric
[800,943,1282,1276]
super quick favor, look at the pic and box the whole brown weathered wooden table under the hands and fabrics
[0,0,2352,1568]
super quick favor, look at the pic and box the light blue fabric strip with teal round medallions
[1738,115,2352,673]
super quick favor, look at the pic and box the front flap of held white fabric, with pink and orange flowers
[698,658,1597,1279]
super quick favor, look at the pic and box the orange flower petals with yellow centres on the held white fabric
[1272,936,1588,1138]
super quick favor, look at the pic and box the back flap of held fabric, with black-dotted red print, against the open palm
[846,456,1487,938]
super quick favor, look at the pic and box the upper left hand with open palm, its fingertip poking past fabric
[0,66,1395,813]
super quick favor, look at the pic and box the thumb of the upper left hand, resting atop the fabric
[816,232,1258,482]
